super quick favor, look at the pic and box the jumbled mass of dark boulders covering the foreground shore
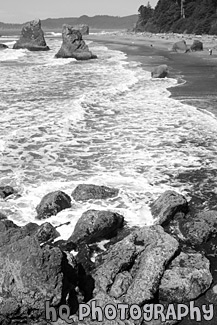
[0,184,217,325]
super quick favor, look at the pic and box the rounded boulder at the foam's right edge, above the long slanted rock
[151,191,188,225]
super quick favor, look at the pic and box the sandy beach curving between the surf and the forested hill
[85,33,217,117]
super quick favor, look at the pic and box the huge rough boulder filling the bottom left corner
[0,230,64,323]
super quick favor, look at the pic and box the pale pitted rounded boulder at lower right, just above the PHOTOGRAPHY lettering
[159,252,212,303]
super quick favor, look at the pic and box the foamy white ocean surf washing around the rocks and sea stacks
[0,34,217,239]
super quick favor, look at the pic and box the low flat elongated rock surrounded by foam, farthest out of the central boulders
[72,184,119,201]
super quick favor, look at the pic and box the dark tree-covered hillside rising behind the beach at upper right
[136,0,217,34]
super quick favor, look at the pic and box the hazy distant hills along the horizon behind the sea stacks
[0,15,137,30]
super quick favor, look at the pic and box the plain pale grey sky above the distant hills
[0,0,158,23]
